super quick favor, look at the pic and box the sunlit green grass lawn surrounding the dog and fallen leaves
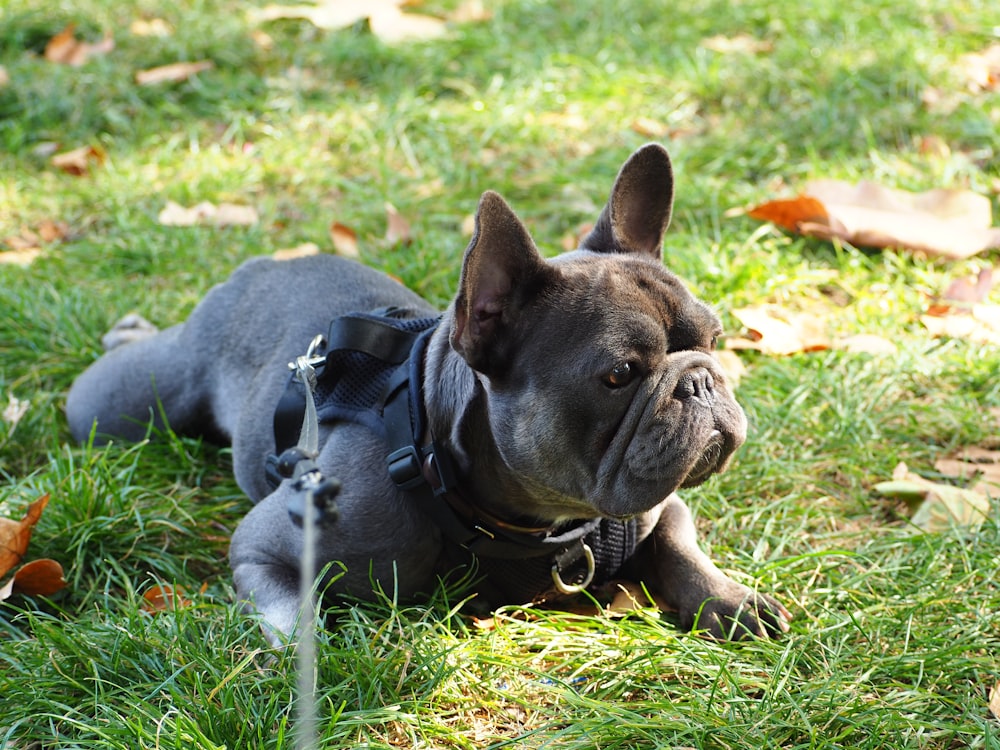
[0,0,1000,750]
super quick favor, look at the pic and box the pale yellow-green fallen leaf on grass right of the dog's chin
[874,463,990,533]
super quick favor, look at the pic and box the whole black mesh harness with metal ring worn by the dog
[266,308,637,601]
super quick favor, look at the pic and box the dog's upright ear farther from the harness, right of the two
[580,143,674,260]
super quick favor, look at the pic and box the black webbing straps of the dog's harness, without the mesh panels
[265,311,634,592]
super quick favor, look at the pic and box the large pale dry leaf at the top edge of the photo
[256,0,446,44]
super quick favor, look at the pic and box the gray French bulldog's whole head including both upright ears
[451,144,746,519]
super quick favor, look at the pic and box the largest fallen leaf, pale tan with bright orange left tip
[747,180,1000,259]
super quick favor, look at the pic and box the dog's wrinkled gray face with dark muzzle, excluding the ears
[485,252,746,518]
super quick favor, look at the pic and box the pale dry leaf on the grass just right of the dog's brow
[726,305,832,355]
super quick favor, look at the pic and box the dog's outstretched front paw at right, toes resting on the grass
[681,580,792,641]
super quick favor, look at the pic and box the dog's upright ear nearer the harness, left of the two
[451,191,552,375]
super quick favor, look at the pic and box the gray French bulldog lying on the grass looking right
[66,144,791,639]
